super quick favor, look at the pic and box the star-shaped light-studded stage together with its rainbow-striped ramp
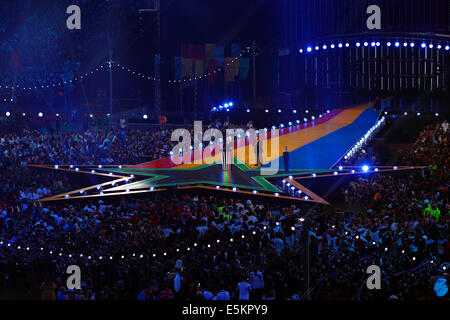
[32,103,426,204]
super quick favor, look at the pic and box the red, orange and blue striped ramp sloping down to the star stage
[132,104,380,169]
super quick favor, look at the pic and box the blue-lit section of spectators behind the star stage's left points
[0,127,171,207]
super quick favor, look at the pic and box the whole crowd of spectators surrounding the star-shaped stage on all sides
[0,118,450,300]
